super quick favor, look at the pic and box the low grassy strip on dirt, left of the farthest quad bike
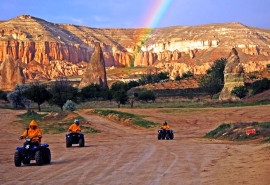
[94,109,158,128]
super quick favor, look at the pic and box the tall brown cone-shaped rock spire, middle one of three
[79,43,108,88]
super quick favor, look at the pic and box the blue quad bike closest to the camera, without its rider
[14,138,51,167]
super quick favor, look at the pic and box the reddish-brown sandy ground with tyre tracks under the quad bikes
[0,105,270,185]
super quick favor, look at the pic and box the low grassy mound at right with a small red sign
[204,122,270,142]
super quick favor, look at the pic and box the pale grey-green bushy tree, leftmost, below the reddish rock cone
[7,84,30,109]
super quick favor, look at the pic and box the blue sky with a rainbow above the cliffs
[0,0,270,29]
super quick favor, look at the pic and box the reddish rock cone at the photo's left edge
[0,55,25,91]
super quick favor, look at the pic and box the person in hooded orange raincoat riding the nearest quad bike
[20,120,42,145]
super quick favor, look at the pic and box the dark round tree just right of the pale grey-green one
[23,82,52,111]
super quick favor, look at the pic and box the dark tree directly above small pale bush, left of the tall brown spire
[50,77,78,110]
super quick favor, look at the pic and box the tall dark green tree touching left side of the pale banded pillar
[199,58,226,98]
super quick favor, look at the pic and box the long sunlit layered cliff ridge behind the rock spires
[0,15,270,89]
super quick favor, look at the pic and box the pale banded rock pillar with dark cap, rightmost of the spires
[219,48,245,101]
